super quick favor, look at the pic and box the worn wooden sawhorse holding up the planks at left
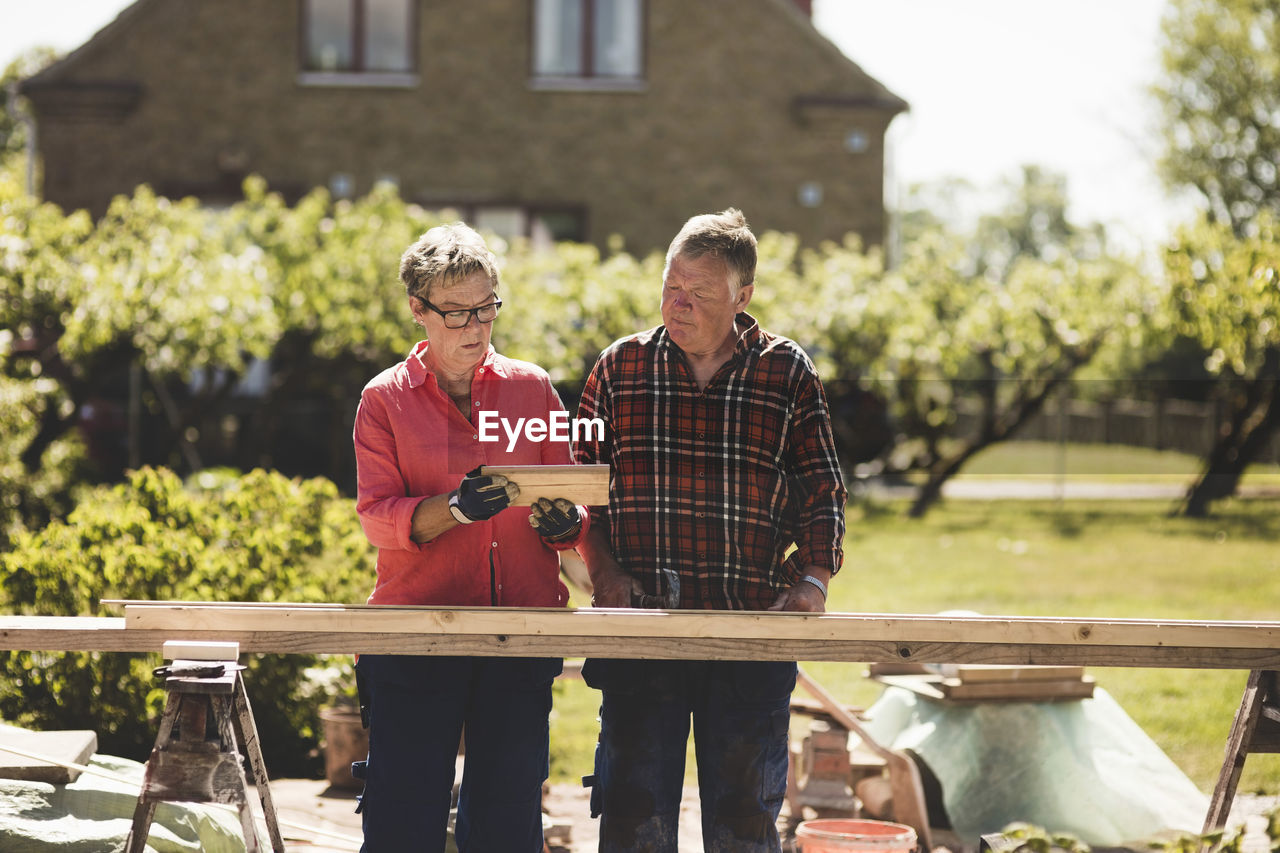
[124,642,284,853]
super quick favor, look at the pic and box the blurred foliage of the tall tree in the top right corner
[1155,0,1280,231]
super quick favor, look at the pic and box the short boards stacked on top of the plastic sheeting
[868,663,1093,702]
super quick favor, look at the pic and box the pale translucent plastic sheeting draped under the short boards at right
[867,686,1208,847]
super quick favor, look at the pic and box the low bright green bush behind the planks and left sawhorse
[0,469,372,775]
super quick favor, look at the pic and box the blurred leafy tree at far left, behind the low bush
[0,169,278,471]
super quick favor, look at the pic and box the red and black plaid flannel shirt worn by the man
[575,314,846,610]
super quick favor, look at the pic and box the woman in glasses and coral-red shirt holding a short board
[355,223,588,853]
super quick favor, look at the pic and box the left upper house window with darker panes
[302,0,417,74]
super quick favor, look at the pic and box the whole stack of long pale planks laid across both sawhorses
[0,602,1280,670]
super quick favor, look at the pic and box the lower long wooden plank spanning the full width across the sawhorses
[0,608,1280,670]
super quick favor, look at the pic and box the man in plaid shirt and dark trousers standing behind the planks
[575,209,845,853]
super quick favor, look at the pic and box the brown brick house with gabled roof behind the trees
[22,0,906,251]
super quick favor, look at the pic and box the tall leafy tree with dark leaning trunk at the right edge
[1155,0,1280,515]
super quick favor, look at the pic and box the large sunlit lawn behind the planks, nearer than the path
[552,491,1280,794]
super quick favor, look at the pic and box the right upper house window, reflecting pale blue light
[532,0,644,83]
